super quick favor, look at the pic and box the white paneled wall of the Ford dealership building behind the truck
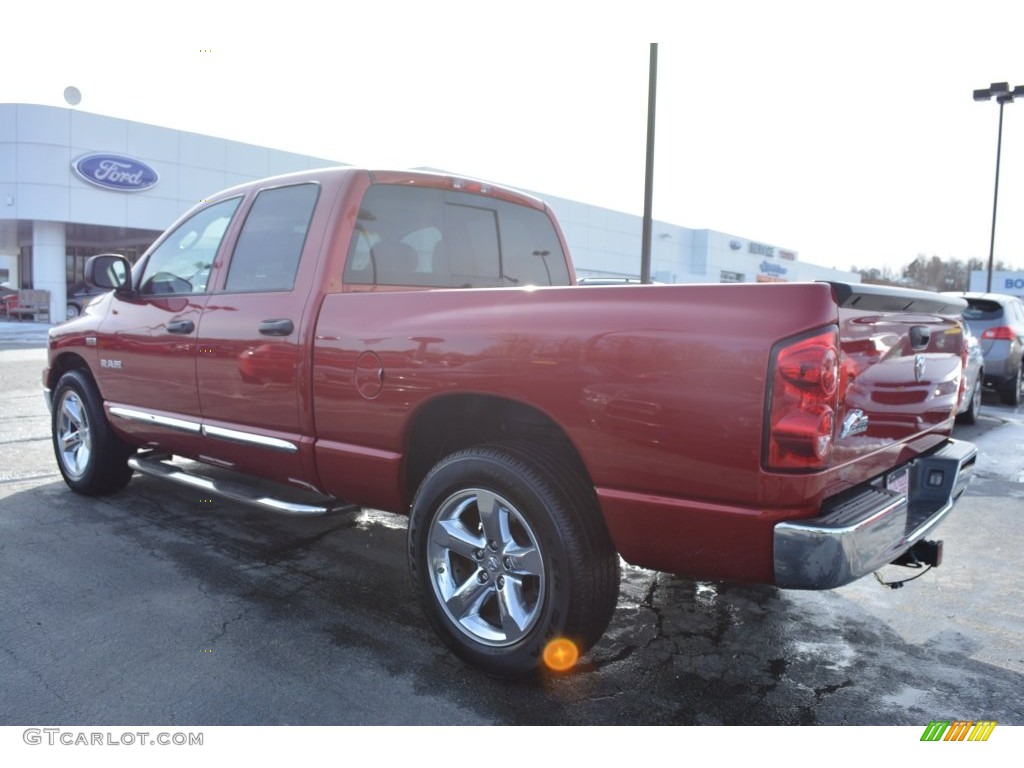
[0,103,860,321]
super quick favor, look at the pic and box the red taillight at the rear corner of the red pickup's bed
[765,328,840,469]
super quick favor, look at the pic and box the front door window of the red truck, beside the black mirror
[139,198,241,296]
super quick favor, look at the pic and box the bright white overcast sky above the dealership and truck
[6,0,1024,269]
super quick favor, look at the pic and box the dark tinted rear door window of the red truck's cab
[224,184,319,292]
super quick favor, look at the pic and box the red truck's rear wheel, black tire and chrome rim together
[409,444,618,677]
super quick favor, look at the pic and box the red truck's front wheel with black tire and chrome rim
[50,371,134,496]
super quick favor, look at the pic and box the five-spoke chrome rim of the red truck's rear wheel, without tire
[427,487,546,647]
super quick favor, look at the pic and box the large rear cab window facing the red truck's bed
[344,184,569,288]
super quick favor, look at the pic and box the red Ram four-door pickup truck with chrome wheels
[43,168,976,675]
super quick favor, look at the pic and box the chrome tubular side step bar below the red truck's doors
[128,453,359,515]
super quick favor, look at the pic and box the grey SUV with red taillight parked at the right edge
[951,292,1024,406]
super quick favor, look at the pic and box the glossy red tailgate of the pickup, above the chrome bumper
[833,284,966,468]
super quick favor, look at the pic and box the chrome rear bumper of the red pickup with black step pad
[774,439,978,590]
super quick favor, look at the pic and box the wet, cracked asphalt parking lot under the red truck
[0,329,1024,727]
